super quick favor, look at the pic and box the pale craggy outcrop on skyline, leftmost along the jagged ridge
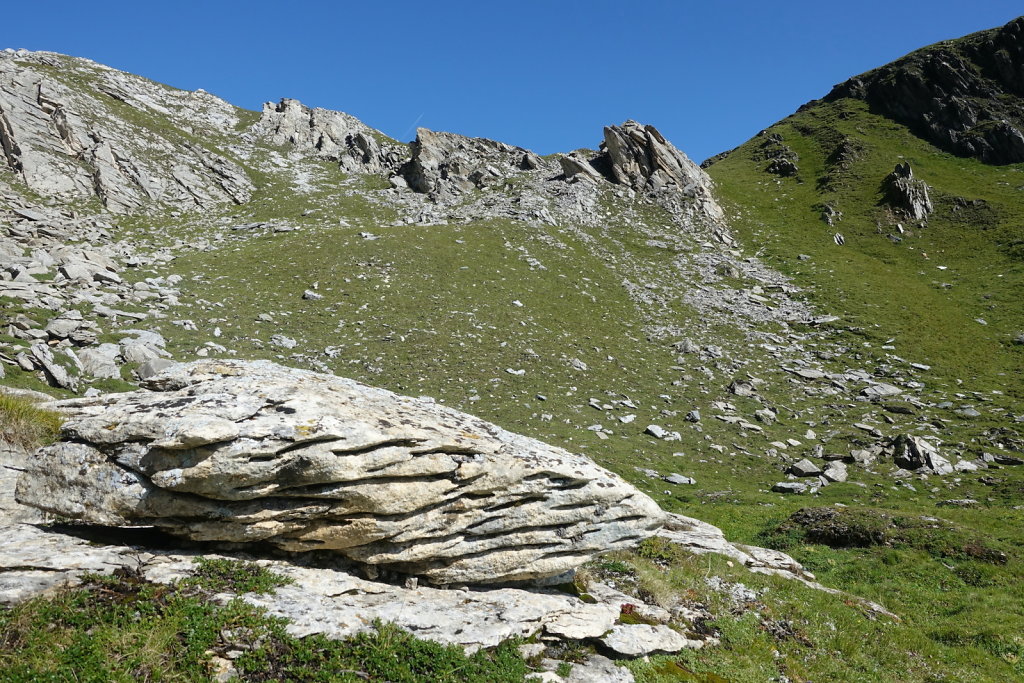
[253,98,402,173]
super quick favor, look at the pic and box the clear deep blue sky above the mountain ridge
[0,0,1024,161]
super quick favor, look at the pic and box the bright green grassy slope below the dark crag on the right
[708,99,1024,400]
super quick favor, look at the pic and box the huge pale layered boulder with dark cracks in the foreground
[17,360,665,584]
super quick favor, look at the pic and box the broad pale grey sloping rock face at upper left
[0,51,254,213]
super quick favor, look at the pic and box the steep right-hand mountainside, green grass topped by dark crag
[703,14,1024,676]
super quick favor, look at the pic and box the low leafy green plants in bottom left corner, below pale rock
[0,562,527,683]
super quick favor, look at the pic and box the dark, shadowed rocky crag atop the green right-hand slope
[825,17,1024,164]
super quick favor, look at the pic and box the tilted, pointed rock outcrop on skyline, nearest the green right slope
[601,121,723,220]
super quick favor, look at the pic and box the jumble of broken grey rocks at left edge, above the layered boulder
[0,199,179,389]
